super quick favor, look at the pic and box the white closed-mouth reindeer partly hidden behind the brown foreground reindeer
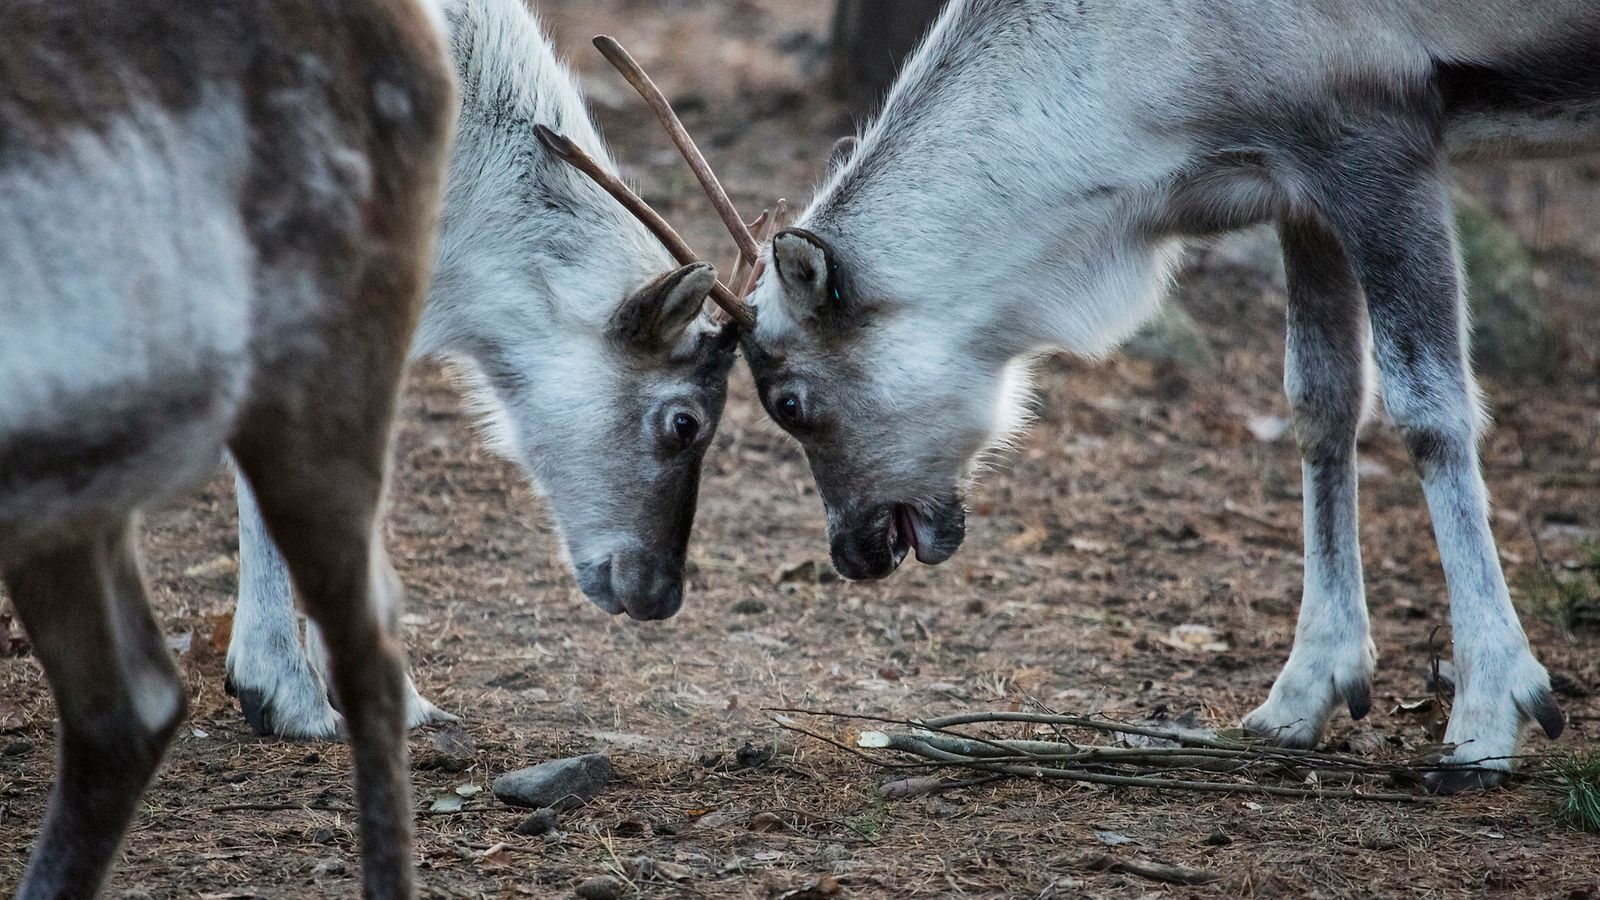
[227,0,748,738]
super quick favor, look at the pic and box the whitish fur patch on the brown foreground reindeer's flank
[0,93,253,560]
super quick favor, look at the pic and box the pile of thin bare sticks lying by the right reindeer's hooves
[771,709,1548,804]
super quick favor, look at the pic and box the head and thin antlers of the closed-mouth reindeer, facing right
[509,38,755,620]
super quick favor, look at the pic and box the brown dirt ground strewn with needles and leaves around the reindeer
[0,0,1600,900]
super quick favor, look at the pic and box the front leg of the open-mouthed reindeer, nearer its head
[1245,223,1378,748]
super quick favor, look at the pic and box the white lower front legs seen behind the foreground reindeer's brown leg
[227,461,454,740]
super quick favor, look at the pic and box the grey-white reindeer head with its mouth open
[744,219,1026,578]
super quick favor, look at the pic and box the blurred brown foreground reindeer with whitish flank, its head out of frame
[0,0,454,900]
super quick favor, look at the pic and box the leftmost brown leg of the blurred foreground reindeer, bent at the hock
[6,522,186,900]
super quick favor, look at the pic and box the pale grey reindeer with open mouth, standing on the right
[744,0,1600,793]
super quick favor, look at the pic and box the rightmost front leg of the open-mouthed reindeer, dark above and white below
[1314,133,1565,793]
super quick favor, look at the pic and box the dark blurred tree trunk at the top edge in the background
[834,0,944,117]
